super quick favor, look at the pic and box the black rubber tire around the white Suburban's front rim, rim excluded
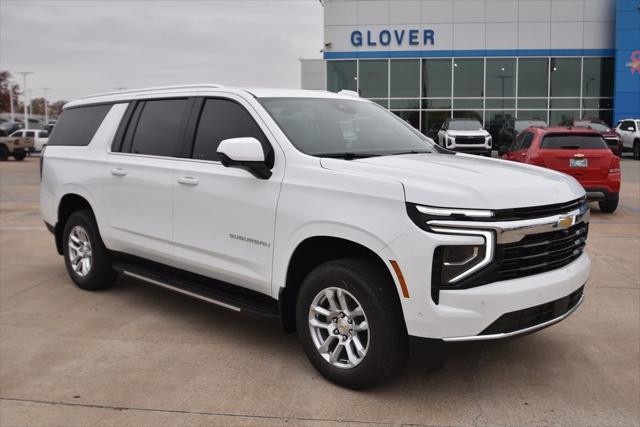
[296,258,409,390]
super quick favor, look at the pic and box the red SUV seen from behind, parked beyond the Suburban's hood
[503,127,621,212]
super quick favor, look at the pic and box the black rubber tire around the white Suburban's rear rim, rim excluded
[62,210,116,291]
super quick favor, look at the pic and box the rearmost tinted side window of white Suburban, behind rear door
[47,105,111,146]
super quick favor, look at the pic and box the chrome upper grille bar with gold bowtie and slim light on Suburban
[427,203,590,243]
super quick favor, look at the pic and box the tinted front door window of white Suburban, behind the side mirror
[192,99,271,160]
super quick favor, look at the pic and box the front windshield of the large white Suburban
[259,98,435,158]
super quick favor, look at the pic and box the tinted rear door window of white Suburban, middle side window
[131,99,188,157]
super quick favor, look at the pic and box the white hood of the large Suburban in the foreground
[320,153,585,209]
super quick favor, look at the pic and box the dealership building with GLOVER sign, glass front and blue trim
[301,0,640,133]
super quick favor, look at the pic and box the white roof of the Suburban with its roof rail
[64,84,370,108]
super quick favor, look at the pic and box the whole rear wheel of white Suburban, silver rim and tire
[63,210,116,291]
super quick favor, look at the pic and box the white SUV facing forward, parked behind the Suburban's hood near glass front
[438,119,492,157]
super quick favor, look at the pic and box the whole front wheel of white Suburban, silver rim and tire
[296,259,408,390]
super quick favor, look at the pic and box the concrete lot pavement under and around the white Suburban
[0,158,640,426]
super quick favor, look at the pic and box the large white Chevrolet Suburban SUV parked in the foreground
[40,85,590,389]
